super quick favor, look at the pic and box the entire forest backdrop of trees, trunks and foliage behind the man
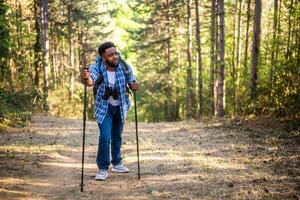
[0,0,300,123]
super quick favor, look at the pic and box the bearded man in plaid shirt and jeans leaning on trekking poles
[81,42,139,180]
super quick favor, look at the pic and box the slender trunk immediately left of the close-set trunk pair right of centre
[195,0,204,115]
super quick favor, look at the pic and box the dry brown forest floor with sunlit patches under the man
[0,116,300,200]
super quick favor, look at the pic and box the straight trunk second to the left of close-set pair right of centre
[186,0,195,118]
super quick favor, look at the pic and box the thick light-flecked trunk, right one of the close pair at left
[41,0,49,112]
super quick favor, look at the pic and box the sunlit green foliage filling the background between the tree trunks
[0,0,300,124]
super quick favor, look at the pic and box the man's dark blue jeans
[96,104,124,169]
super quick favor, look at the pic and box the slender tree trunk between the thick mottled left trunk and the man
[68,0,74,100]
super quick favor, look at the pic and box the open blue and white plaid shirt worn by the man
[90,57,136,124]
